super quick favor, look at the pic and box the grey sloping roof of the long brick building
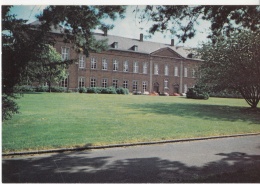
[31,21,199,60]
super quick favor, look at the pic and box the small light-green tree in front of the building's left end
[27,45,71,92]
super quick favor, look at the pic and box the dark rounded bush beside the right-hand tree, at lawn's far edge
[186,85,209,100]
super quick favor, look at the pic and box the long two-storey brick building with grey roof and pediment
[33,20,201,95]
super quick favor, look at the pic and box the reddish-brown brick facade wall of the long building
[55,35,200,95]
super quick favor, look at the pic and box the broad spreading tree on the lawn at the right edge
[198,30,260,108]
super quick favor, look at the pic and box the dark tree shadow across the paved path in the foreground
[2,152,260,183]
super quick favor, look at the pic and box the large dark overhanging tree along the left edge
[2,6,125,119]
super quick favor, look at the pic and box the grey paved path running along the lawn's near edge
[2,135,260,183]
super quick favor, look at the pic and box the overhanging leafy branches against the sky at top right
[136,5,260,42]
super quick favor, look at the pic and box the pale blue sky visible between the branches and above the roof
[7,0,255,47]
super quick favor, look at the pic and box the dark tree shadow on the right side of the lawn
[126,103,260,124]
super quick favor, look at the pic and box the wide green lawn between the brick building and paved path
[2,93,260,152]
